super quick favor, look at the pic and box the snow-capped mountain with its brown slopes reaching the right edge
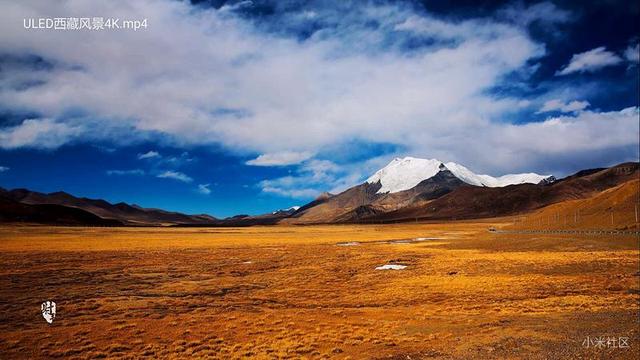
[283,158,639,224]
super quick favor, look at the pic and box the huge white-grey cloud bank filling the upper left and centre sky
[0,1,544,156]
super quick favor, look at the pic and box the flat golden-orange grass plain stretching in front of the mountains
[0,224,640,359]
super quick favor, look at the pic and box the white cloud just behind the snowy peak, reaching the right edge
[400,107,640,175]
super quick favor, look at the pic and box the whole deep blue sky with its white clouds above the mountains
[0,0,640,217]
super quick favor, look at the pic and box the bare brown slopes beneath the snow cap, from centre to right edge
[282,163,639,224]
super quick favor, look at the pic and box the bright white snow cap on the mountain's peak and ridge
[366,157,549,194]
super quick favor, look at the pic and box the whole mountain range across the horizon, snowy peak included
[0,157,639,226]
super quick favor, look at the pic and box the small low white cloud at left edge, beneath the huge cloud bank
[0,119,83,149]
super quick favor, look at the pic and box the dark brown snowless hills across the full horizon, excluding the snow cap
[0,163,640,227]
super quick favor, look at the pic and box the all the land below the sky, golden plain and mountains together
[0,158,640,360]
